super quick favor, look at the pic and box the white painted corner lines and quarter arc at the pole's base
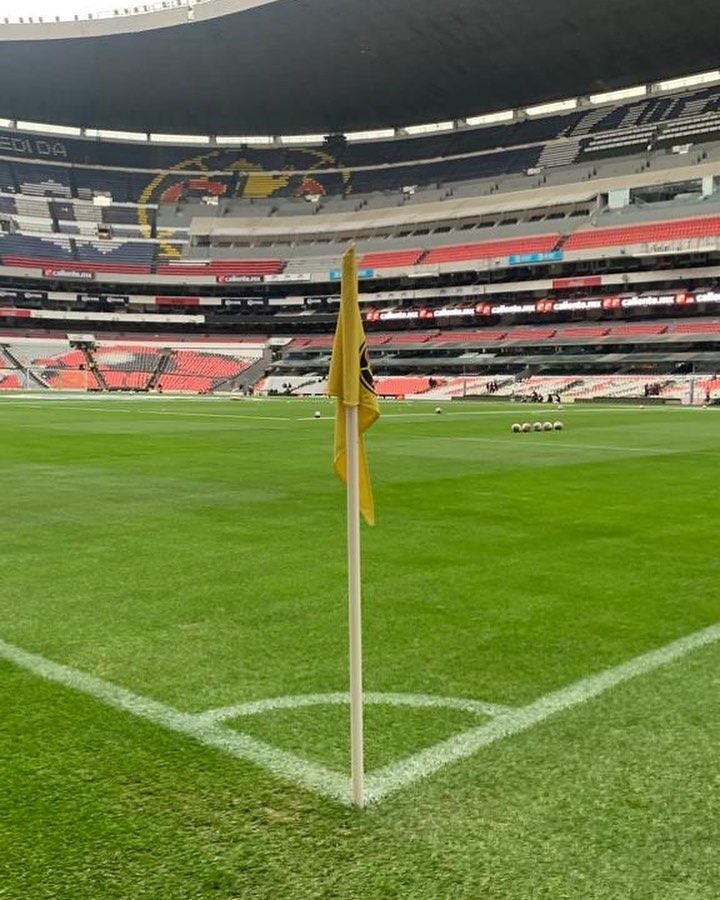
[0,624,720,804]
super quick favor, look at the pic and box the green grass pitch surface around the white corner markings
[0,398,720,900]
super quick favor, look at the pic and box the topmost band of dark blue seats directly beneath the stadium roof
[0,85,720,218]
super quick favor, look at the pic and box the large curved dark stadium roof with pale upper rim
[0,0,720,135]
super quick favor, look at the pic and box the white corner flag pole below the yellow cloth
[345,406,365,809]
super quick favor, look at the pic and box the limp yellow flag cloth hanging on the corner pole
[327,246,380,525]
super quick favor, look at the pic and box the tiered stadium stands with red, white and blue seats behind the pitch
[0,86,720,402]
